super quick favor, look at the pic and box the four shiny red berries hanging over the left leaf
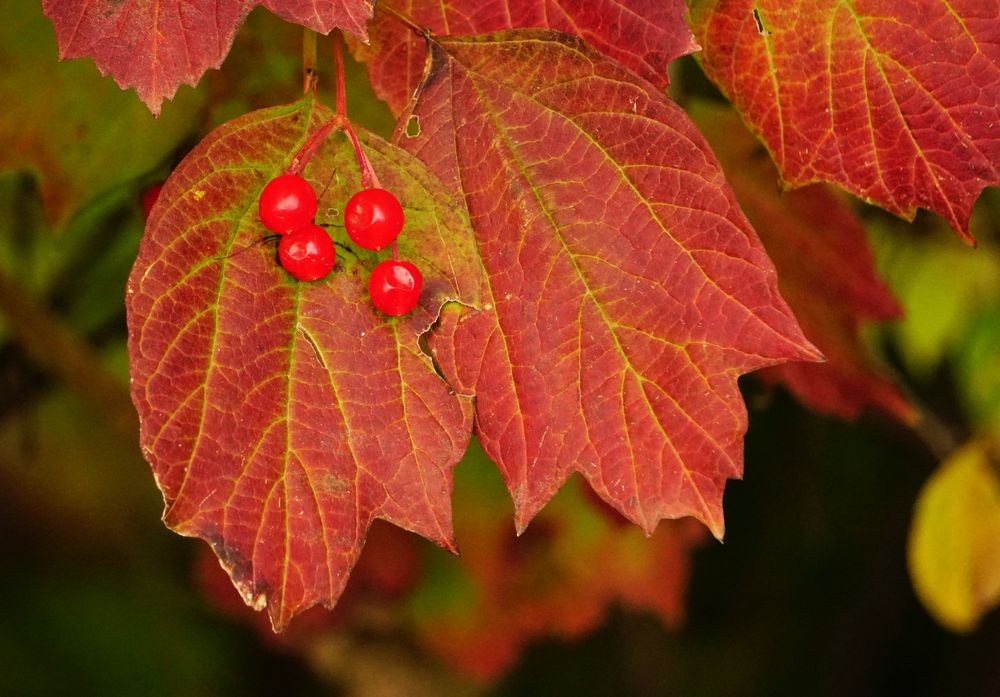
[258,174,423,315]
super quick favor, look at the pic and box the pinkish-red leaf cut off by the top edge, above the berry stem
[42,0,372,114]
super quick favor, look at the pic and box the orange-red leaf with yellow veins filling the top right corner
[689,0,1000,241]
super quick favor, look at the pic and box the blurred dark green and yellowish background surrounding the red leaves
[0,2,1000,697]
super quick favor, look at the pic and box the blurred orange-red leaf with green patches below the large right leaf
[408,447,708,680]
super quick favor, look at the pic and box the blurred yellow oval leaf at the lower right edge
[909,441,1000,632]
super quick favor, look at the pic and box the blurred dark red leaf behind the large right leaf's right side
[688,102,914,421]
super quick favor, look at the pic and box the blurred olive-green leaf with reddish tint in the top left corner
[0,2,202,229]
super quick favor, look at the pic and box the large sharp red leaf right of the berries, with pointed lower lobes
[404,30,817,537]
